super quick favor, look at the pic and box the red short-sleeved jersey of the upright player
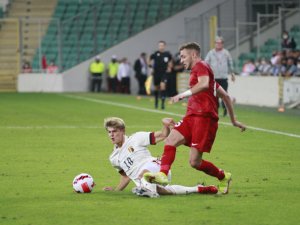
[186,61,219,119]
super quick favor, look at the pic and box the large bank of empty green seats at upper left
[32,0,199,70]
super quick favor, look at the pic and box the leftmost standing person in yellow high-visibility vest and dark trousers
[90,56,105,92]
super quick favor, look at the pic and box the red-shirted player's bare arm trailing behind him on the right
[217,86,246,132]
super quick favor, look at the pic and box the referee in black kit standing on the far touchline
[149,41,172,109]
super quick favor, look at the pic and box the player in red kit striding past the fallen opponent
[144,43,246,194]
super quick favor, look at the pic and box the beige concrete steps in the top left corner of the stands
[0,0,56,91]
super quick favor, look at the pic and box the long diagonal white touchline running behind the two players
[63,95,300,138]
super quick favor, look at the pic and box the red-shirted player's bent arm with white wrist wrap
[171,75,209,103]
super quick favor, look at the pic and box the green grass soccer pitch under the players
[0,93,300,225]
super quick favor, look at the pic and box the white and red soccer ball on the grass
[73,173,95,193]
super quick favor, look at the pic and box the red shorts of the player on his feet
[174,116,218,152]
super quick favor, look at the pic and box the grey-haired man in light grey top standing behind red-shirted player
[205,37,235,116]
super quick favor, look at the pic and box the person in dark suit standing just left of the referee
[134,52,148,95]
